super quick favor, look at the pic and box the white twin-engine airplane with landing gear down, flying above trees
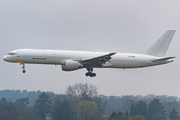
[3,30,176,77]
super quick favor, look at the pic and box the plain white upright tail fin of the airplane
[143,30,176,57]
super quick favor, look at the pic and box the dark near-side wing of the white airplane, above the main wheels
[80,53,116,65]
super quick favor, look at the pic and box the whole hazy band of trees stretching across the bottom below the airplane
[0,83,180,120]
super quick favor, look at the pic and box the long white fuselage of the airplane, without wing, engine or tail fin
[3,49,173,69]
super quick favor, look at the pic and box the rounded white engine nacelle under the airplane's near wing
[62,60,83,71]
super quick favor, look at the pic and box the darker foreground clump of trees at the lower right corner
[110,98,180,120]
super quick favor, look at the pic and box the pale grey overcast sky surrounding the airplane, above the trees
[0,0,180,97]
